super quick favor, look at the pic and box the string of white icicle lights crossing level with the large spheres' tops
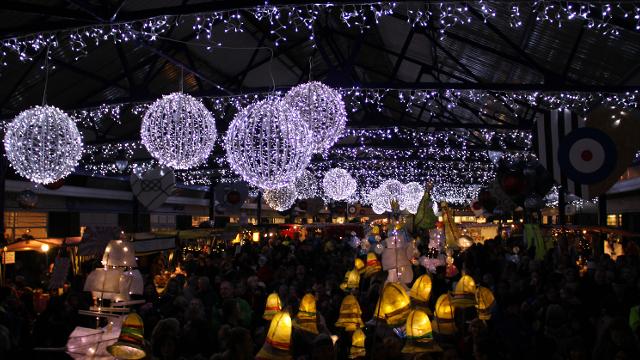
[7,88,640,129]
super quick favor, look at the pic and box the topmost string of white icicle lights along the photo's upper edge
[0,0,640,65]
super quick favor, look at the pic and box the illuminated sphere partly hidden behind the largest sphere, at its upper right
[285,81,347,153]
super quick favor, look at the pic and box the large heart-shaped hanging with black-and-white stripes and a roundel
[534,108,640,200]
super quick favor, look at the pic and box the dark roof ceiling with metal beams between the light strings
[0,0,640,191]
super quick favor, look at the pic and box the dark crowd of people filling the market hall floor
[0,225,640,360]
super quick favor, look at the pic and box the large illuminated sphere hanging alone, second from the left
[140,92,217,170]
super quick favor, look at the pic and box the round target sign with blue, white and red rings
[558,127,618,184]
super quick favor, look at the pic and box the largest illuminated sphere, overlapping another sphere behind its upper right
[224,97,312,189]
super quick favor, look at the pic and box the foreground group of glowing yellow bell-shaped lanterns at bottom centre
[256,274,495,359]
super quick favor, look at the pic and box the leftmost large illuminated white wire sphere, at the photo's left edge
[4,105,82,184]
